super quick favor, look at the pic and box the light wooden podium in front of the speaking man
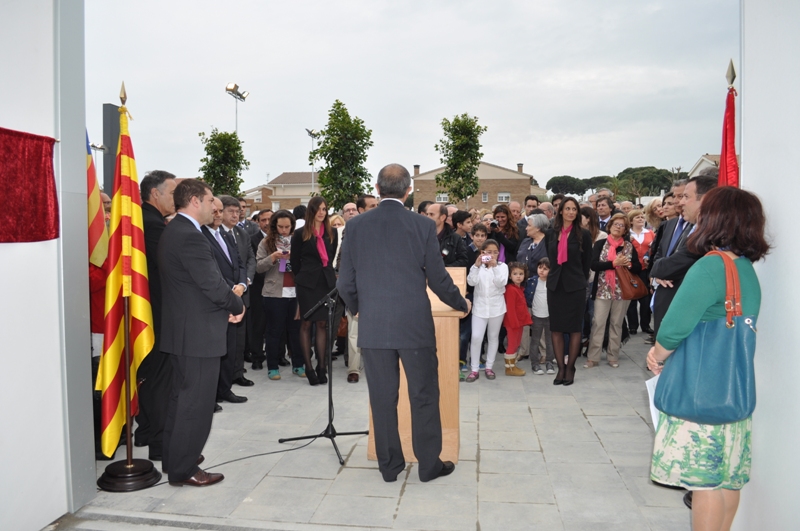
[367,267,467,463]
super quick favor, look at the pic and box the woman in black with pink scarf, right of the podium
[545,197,592,385]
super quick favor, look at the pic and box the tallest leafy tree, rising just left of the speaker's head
[308,100,372,210]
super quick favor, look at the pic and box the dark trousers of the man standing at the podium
[361,347,443,481]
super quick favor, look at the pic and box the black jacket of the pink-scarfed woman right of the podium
[545,229,592,293]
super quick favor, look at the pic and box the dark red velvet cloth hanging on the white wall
[0,127,59,243]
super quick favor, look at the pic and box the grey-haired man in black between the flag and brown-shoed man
[134,170,178,461]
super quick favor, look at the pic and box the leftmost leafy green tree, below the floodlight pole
[198,127,250,197]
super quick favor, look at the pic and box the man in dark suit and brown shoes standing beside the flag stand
[158,179,244,486]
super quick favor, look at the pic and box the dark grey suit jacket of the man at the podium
[338,200,467,349]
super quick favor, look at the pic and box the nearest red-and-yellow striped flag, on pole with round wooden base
[95,102,155,457]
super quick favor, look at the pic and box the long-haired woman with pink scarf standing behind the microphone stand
[290,196,338,385]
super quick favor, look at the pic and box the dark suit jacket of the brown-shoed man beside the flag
[158,214,243,358]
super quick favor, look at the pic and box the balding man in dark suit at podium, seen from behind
[337,164,470,481]
